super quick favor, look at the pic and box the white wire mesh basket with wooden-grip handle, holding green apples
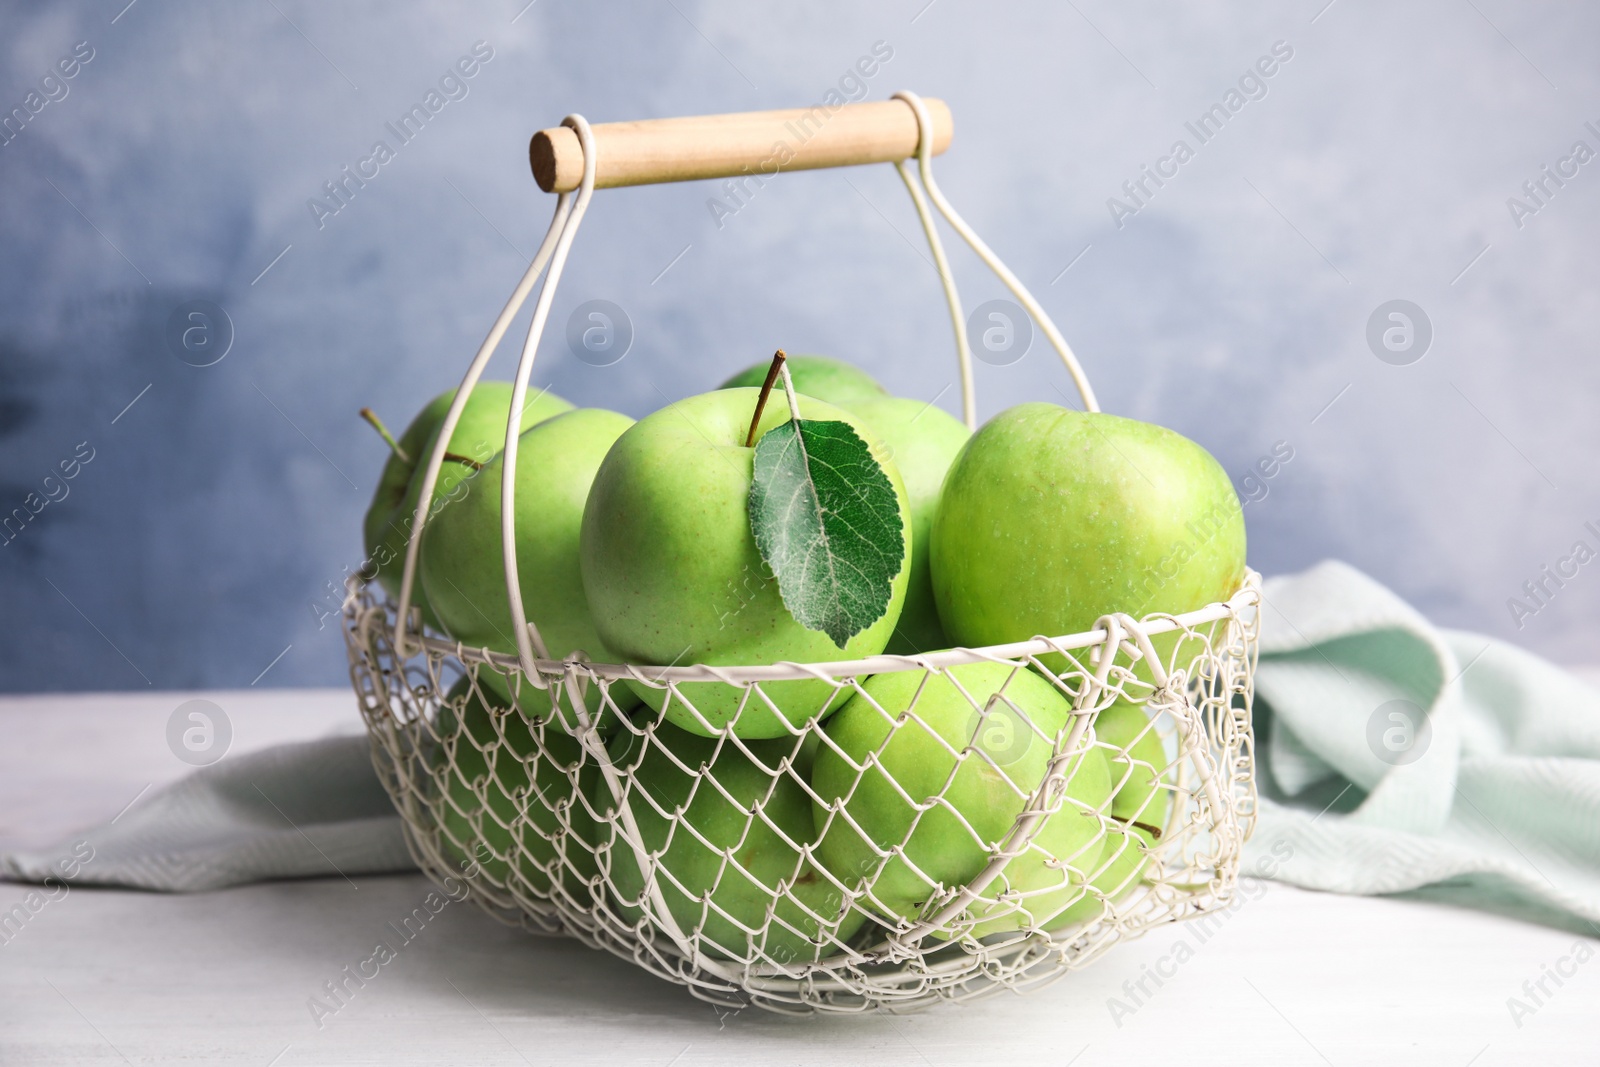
[346,93,1259,1013]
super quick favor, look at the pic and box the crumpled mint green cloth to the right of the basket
[1245,561,1600,928]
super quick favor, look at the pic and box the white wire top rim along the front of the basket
[349,566,1261,688]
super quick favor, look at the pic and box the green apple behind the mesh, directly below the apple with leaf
[592,723,866,965]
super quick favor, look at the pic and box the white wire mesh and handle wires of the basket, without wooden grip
[346,93,1259,1013]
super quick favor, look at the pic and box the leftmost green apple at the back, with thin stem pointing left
[363,381,573,629]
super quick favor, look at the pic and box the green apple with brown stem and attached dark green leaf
[581,352,912,737]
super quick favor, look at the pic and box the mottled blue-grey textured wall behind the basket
[0,0,1600,689]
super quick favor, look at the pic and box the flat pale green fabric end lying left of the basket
[0,736,416,893]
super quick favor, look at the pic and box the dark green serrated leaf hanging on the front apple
[750,419,906,648]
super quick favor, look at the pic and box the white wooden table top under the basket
[0,689,1600,1067]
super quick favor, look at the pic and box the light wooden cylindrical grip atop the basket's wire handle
[528,99,954,192]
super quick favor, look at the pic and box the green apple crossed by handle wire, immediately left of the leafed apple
[418,408,637,729]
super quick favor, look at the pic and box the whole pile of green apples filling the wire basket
[365,357,1245,965]
